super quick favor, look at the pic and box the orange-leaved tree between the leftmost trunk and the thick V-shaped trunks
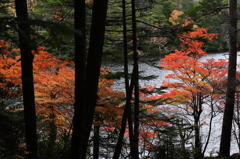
[33,47,74,158]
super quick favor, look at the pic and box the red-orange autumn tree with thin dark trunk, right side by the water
[161,28,227,158]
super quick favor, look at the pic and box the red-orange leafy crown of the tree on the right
[161,28,228,108]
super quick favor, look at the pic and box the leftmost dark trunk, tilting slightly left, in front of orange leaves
[15,0,37,159]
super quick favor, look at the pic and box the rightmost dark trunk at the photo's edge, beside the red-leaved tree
[220,0,237,156]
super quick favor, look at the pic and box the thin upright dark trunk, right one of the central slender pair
[132,0,139,159]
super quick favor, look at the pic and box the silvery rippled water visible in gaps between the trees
[104,52,240,156]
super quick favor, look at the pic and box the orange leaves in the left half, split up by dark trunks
[0,41,124,137]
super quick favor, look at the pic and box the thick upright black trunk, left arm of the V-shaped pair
[70,0,87,159]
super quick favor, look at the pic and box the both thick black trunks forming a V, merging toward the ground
[70,0,108,159]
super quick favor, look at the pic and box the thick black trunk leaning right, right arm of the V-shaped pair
[80,0,108,159]
